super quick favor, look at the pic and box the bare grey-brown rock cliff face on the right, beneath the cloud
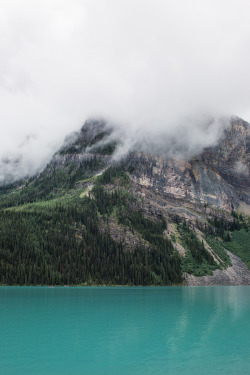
[126,119,250,212]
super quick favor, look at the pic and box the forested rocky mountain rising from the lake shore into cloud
[0,118,250,285]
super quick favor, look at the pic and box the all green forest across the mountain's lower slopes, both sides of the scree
[0,156,249,285]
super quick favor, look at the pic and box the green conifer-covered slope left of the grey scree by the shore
[0,163,182,285]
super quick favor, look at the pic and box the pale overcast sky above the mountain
[0,0,250,181]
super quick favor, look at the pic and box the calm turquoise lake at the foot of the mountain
[0,286,250,375]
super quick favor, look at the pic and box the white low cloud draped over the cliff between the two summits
[108,116,231,160]
